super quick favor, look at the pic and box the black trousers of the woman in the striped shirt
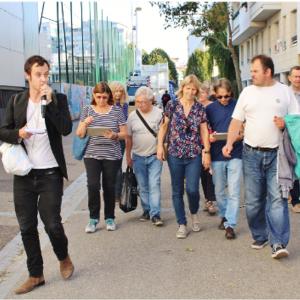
[84,158,120,220]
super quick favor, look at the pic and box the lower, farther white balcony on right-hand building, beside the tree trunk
[231,3,266,45]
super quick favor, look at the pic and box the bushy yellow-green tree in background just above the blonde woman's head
[185,49,213,81]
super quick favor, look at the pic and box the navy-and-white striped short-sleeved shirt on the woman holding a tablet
[80,105,126,160]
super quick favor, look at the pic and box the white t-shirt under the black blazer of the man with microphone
[24,99,58,169]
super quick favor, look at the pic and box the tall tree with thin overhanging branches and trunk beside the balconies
[151,2,242,92]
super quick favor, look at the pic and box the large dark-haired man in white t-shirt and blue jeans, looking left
[223,55,298,259]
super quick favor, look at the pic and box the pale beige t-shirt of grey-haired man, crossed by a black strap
[127,106,163,156]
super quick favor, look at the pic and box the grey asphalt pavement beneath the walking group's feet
[0,164,300,299]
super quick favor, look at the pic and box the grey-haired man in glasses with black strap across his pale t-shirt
[126,86,163,226]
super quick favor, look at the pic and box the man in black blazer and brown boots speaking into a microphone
[0,55,74,294]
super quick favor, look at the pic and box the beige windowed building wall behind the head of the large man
[239,2,300,85]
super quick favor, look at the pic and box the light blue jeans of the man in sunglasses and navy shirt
[212,158,243,228]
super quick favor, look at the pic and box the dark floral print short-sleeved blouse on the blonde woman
[165,100,207,158]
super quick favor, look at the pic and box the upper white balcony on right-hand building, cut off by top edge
[248,2,281,22]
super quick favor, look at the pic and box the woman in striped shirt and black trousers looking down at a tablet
[76,82,127,233]
